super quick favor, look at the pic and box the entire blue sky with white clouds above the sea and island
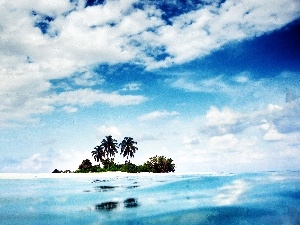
[0,0,300,173]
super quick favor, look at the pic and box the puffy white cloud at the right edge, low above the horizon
[199,101,300,146]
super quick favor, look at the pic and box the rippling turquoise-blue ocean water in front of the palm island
[0,171,300,225]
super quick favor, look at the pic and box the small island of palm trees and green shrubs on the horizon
[52,135,175,173]
